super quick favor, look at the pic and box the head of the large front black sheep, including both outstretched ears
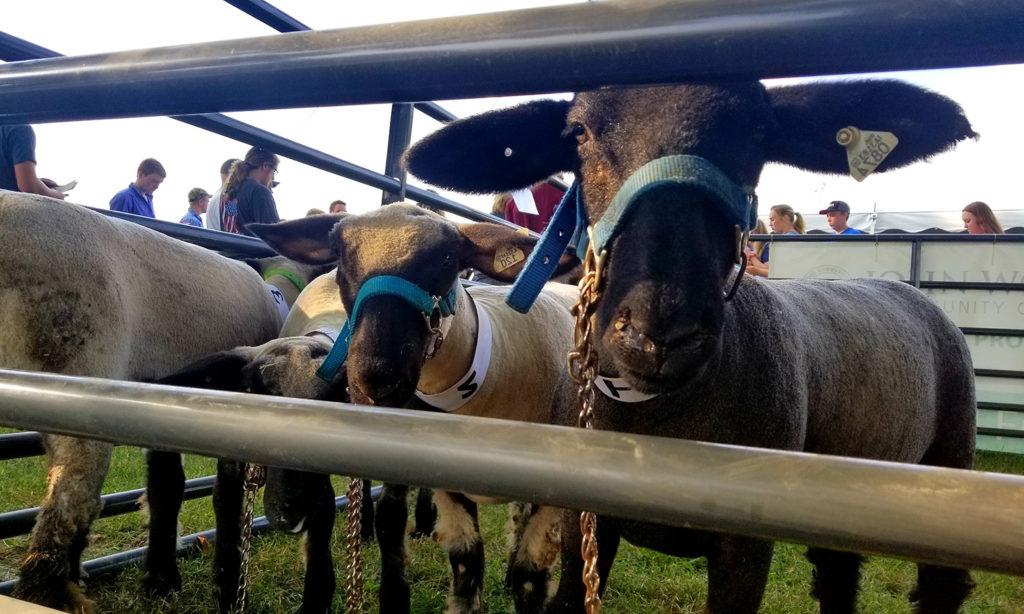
[404,81,976,392]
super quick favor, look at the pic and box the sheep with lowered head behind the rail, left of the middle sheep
[151,273,344,613]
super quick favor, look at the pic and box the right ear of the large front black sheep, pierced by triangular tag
[767,80,978,174]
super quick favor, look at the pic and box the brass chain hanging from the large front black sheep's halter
[568,237,608,614]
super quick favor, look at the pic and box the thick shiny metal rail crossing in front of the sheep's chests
[0,370,1024,575]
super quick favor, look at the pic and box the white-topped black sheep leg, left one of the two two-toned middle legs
[434,490,483,614]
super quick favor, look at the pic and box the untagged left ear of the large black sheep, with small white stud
[402,100,577,193]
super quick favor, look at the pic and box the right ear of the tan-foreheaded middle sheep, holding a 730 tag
[459,224,580,281]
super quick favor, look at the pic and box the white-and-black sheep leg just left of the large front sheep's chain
[506,503,561,614]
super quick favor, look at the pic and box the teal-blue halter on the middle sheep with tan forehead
[316,275,459,383]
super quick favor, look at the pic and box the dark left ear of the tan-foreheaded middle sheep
[246,213,347,264]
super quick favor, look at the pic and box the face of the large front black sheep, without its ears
[566,83,770,392]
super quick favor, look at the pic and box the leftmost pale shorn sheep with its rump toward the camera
[0,191,323,612]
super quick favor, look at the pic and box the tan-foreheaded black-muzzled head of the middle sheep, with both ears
[249,203,578,407]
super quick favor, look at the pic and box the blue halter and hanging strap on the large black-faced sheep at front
[505,155,758,313]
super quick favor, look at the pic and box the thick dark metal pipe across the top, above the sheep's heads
[0,0,1024,123]
